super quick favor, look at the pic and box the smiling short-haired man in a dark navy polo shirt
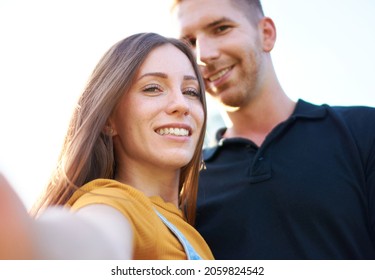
[173,0,375,259]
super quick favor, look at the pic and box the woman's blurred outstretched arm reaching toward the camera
[0,175,133,259]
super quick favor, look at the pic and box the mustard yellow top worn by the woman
[67,179,213,260]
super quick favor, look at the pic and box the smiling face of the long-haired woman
[110,44,204,173]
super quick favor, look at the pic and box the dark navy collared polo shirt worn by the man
[196,100,375,259]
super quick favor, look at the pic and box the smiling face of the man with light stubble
[176,0,262,111]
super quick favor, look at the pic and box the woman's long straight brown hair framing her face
[31,33,207,224]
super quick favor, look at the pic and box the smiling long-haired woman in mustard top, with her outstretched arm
[0,33,213,259]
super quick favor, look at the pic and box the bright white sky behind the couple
[0,0,375,207]
